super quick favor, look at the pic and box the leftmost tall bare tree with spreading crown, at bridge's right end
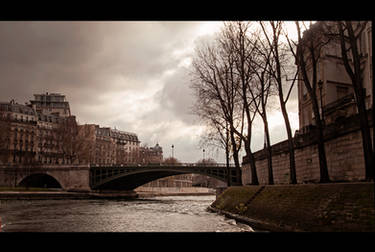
[191,32,244,184]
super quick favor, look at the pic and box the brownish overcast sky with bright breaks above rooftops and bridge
[0,21,298,162]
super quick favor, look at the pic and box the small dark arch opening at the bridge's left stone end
[17,173,63,188]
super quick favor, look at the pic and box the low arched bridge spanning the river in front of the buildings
[0,163,241,191]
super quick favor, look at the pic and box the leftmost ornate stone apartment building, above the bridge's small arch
[0,100,75,164]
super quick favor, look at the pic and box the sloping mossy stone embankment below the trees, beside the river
[211,182,375,232]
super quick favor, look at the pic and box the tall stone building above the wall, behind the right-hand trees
[298,21,373,133]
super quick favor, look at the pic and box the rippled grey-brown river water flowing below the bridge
[0,195,253,232]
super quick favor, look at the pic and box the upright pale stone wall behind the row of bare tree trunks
[242,112,373,185]
